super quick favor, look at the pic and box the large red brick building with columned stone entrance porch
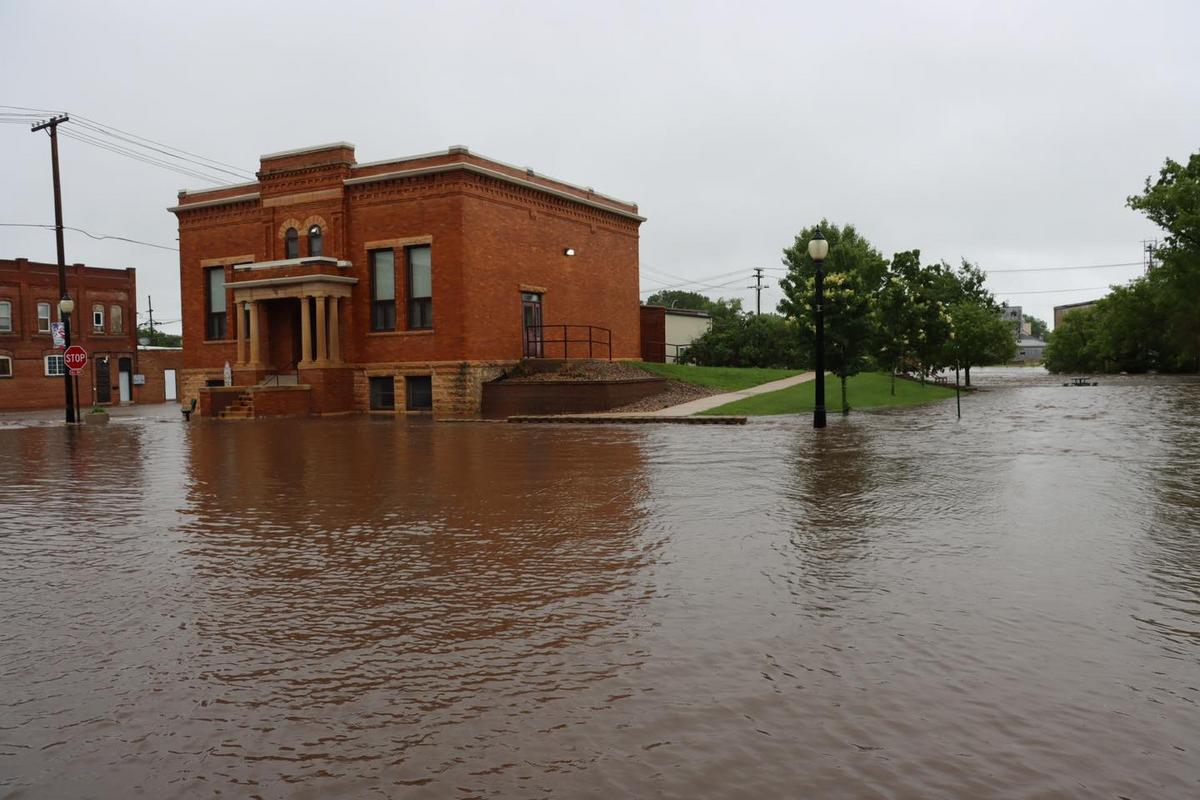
[170,143,643,417]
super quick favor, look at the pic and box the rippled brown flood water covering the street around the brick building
[0,371,1200,799]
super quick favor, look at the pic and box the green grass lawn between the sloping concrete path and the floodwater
[703,372,954,416]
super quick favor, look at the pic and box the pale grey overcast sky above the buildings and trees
[0,0,1200,331]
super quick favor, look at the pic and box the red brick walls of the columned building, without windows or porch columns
[178,145,641,417]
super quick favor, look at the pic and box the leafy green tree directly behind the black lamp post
[779,219,887,414]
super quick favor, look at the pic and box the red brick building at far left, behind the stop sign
[0,258,137,410]
